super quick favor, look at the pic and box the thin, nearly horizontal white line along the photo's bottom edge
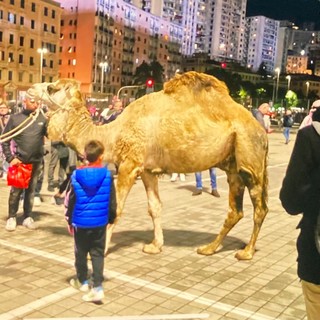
[26,313,209,320]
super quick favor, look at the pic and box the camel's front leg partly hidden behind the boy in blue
[105,162,143,255]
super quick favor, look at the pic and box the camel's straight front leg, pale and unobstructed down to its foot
[141,171,163,254]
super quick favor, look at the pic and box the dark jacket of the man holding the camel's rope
[2,110,47,163]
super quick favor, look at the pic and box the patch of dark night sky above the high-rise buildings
[247,0,320,30]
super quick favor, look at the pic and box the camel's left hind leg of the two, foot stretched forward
[197,173,245,255]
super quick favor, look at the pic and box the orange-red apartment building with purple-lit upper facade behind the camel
[60,0,183,97]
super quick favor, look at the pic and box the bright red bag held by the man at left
[7,163,32,189]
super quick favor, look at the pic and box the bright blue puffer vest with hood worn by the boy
[71,167,112,228]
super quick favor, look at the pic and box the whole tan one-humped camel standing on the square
[29,71,268,260]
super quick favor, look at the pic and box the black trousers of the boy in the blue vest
[74,226,106,288]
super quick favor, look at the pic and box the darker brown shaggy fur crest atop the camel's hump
[164,71,229,95]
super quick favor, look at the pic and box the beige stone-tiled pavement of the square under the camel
[0,132,306,320]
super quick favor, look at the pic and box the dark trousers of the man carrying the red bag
[9,162,41,219]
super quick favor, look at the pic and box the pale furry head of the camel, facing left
[27,79,82,111]
